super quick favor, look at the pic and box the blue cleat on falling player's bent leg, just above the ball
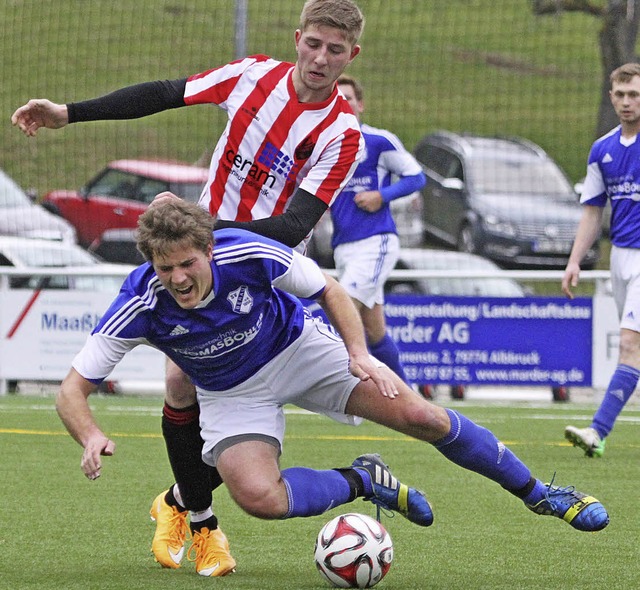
[351,454,433,526]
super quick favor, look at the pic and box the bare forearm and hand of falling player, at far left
[56,369,116,480]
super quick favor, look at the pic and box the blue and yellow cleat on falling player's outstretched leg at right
[526,481,609,532]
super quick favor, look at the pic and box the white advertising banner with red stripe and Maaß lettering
[0,290,164,381]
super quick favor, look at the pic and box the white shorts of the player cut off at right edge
[610,246,640,332]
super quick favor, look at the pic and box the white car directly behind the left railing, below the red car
[0,236,132,295]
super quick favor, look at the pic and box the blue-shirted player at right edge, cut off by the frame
[562,63,640,457]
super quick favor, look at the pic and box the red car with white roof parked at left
[42,160,209,247]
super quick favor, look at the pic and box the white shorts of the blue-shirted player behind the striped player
[333,234,400,309]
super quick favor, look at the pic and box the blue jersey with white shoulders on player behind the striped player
[331,124,425,249]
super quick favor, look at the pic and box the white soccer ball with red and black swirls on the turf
[315,513,393,588]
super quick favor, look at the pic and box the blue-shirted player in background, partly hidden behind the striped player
[330,75,426,381]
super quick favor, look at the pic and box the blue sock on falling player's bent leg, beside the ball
[282,467,353,518]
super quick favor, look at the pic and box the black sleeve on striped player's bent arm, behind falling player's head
[215,189,328,248]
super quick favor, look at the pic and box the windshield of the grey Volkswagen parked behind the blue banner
[469,157,575,200]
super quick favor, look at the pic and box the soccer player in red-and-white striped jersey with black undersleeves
[11,0,364,575]
